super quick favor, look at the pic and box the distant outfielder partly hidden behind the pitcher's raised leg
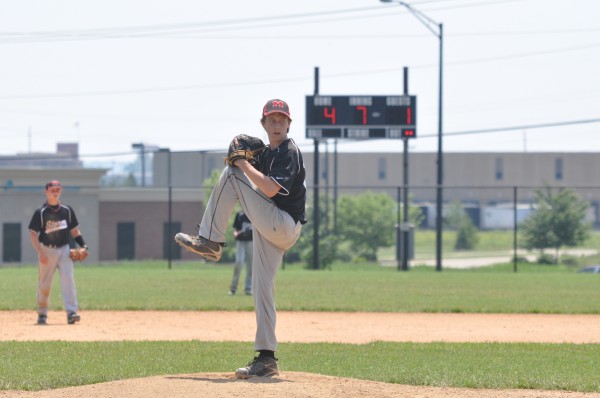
[229,211,252,296]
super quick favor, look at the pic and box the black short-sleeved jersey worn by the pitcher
[256,138,306,224]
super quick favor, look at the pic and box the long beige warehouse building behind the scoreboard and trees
[153,152,600,228]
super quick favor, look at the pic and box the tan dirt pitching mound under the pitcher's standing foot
[0,372,600,398]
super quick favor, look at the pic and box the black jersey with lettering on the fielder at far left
[29,203,79,247]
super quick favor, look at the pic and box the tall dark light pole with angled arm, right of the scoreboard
[379,0,444,271]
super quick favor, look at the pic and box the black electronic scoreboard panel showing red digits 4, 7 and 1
[306,95,417,139]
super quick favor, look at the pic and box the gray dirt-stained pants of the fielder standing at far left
[37,244,79,315]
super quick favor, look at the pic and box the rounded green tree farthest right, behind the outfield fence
[522,187,591,258]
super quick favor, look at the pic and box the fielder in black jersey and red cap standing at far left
[29,180,87,325]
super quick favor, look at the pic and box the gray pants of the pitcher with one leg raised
[199,167,302,351]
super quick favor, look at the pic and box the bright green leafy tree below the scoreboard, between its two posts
[338,191,398,260]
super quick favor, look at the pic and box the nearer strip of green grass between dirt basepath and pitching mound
[0,341,600,392]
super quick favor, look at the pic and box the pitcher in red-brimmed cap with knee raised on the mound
[175,99,306,379]
